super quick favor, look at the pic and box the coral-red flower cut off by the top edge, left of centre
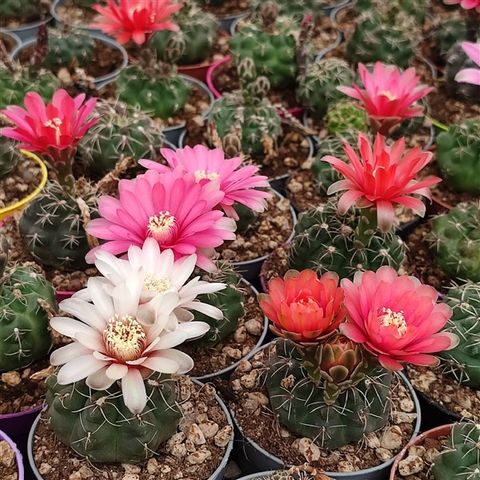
[91,0,182,45]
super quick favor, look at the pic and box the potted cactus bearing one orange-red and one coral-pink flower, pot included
[231,267,457,479]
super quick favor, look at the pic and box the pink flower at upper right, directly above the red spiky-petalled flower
[338,62,433,134]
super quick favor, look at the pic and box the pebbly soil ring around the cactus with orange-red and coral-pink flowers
[230,346,417,472]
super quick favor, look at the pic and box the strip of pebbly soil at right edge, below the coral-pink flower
[407,364,480,423]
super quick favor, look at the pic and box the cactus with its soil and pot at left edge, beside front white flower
[0,237,57,440]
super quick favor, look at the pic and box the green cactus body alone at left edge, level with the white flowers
[0,240,57,372]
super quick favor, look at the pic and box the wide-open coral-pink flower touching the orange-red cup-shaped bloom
[340,267,458,370]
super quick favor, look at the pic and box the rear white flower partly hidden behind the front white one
[74,238,226,328]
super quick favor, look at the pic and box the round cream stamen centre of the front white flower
[103,315,147,362]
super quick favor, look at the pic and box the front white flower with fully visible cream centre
[50,276,209,413]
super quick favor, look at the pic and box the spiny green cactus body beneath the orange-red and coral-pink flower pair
[266,340,392,449]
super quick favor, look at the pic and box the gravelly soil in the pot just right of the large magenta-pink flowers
[218,191,294,262]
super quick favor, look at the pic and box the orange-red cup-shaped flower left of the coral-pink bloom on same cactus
[259,270,345,343]
